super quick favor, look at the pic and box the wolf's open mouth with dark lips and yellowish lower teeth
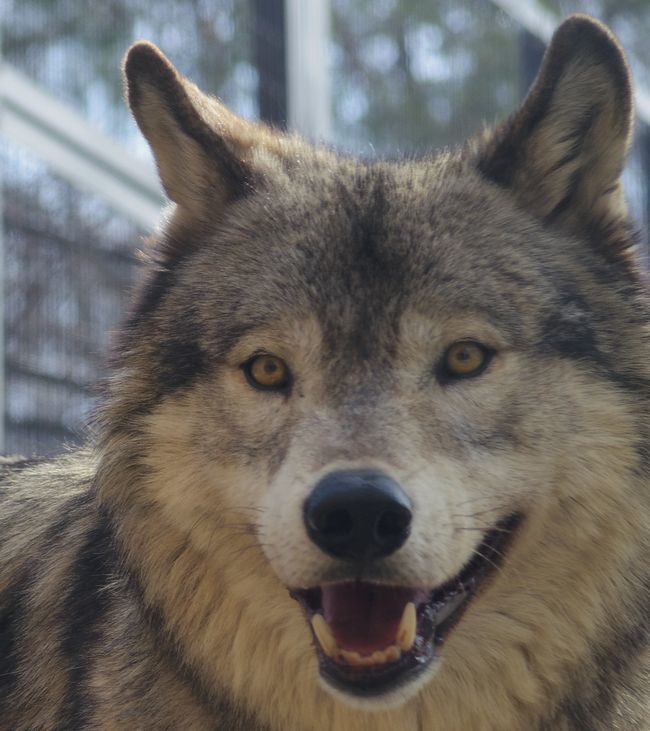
[290,514,521,696]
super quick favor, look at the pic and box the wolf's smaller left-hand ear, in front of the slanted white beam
[124,41,260,216]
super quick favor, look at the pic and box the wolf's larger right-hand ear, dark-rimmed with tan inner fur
[478,15,633,237]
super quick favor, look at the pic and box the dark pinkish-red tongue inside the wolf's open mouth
[321,582,421,655]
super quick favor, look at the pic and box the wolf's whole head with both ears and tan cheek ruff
[102,16,650,727]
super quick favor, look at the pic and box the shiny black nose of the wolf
[304,470,413,561]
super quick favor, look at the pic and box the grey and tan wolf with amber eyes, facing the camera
[0,16,650,731]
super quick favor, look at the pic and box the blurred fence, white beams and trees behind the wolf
[0,0,650,455]
